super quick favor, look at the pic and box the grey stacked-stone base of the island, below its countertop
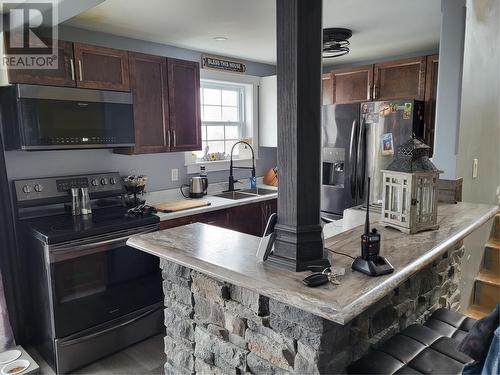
[161,243,464,374]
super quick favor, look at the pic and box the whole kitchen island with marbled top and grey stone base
[127,203,498,373]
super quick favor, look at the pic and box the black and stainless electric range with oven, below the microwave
[13,173,163,373]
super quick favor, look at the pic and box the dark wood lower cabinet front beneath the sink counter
[160,199,278,237]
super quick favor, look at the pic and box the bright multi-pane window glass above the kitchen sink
[196,81,246,158]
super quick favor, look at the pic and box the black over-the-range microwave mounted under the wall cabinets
[0,84,135,151]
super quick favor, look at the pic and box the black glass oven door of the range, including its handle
[49,225,163,338]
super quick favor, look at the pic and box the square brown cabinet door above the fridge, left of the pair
[331,65,373,104]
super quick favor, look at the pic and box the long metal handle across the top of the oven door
[49,229,156,263]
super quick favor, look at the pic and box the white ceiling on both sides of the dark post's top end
[65,0,441,64]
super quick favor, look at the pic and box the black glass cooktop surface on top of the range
[23,207,160,244]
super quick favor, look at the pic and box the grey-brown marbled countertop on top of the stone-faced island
[127,203,498,324]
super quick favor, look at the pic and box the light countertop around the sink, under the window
[145,182,278,221]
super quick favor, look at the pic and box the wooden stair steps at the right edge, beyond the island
[466,214,500,319]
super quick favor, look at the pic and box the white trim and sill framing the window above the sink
[184,69,260,174]
